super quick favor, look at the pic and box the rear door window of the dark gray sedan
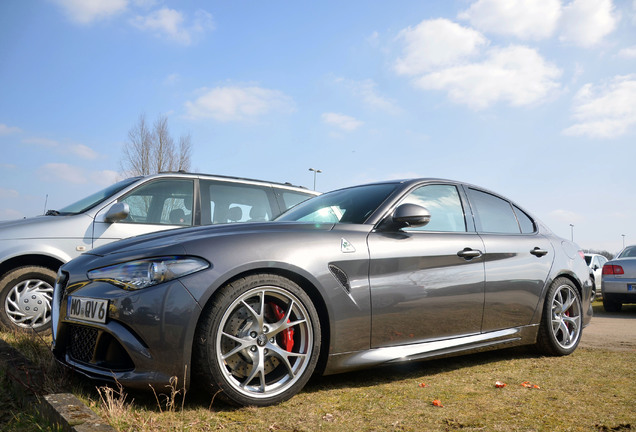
[468,188,523,234]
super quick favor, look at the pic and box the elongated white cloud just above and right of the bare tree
[185,86,294,122]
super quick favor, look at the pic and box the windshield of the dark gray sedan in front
[276,183,396,224]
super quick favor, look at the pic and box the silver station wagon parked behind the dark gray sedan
[0,173,317,331]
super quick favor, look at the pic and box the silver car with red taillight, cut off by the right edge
[601,245,636,312]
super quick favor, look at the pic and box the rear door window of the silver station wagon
[201,180,275,225]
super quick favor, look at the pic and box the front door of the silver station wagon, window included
[93,178,195,247]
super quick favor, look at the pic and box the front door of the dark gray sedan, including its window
[368,184,484,347]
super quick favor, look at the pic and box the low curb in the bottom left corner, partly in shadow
[0,339,116,432]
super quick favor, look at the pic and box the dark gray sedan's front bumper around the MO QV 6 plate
[53,280,201,389]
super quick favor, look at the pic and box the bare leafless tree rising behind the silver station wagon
[121,114,192,176]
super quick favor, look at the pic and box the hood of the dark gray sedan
[86,222,334,256]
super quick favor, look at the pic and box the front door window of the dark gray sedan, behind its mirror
[402,185,466,232]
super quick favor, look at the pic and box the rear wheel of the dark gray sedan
[537,277,583,356]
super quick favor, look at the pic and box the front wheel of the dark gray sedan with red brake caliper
[193,274,321,406]
